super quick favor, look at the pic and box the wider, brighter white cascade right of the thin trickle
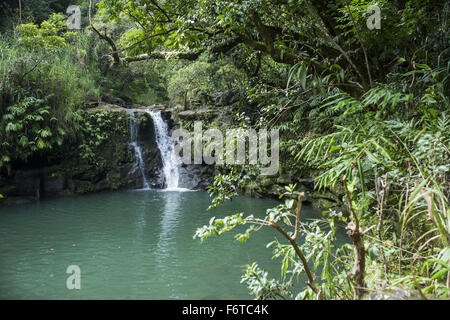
[146,109,182,190]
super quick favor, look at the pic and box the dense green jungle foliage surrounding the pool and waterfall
[0,0,450,299]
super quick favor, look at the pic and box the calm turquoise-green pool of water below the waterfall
[0,191,330,299]
